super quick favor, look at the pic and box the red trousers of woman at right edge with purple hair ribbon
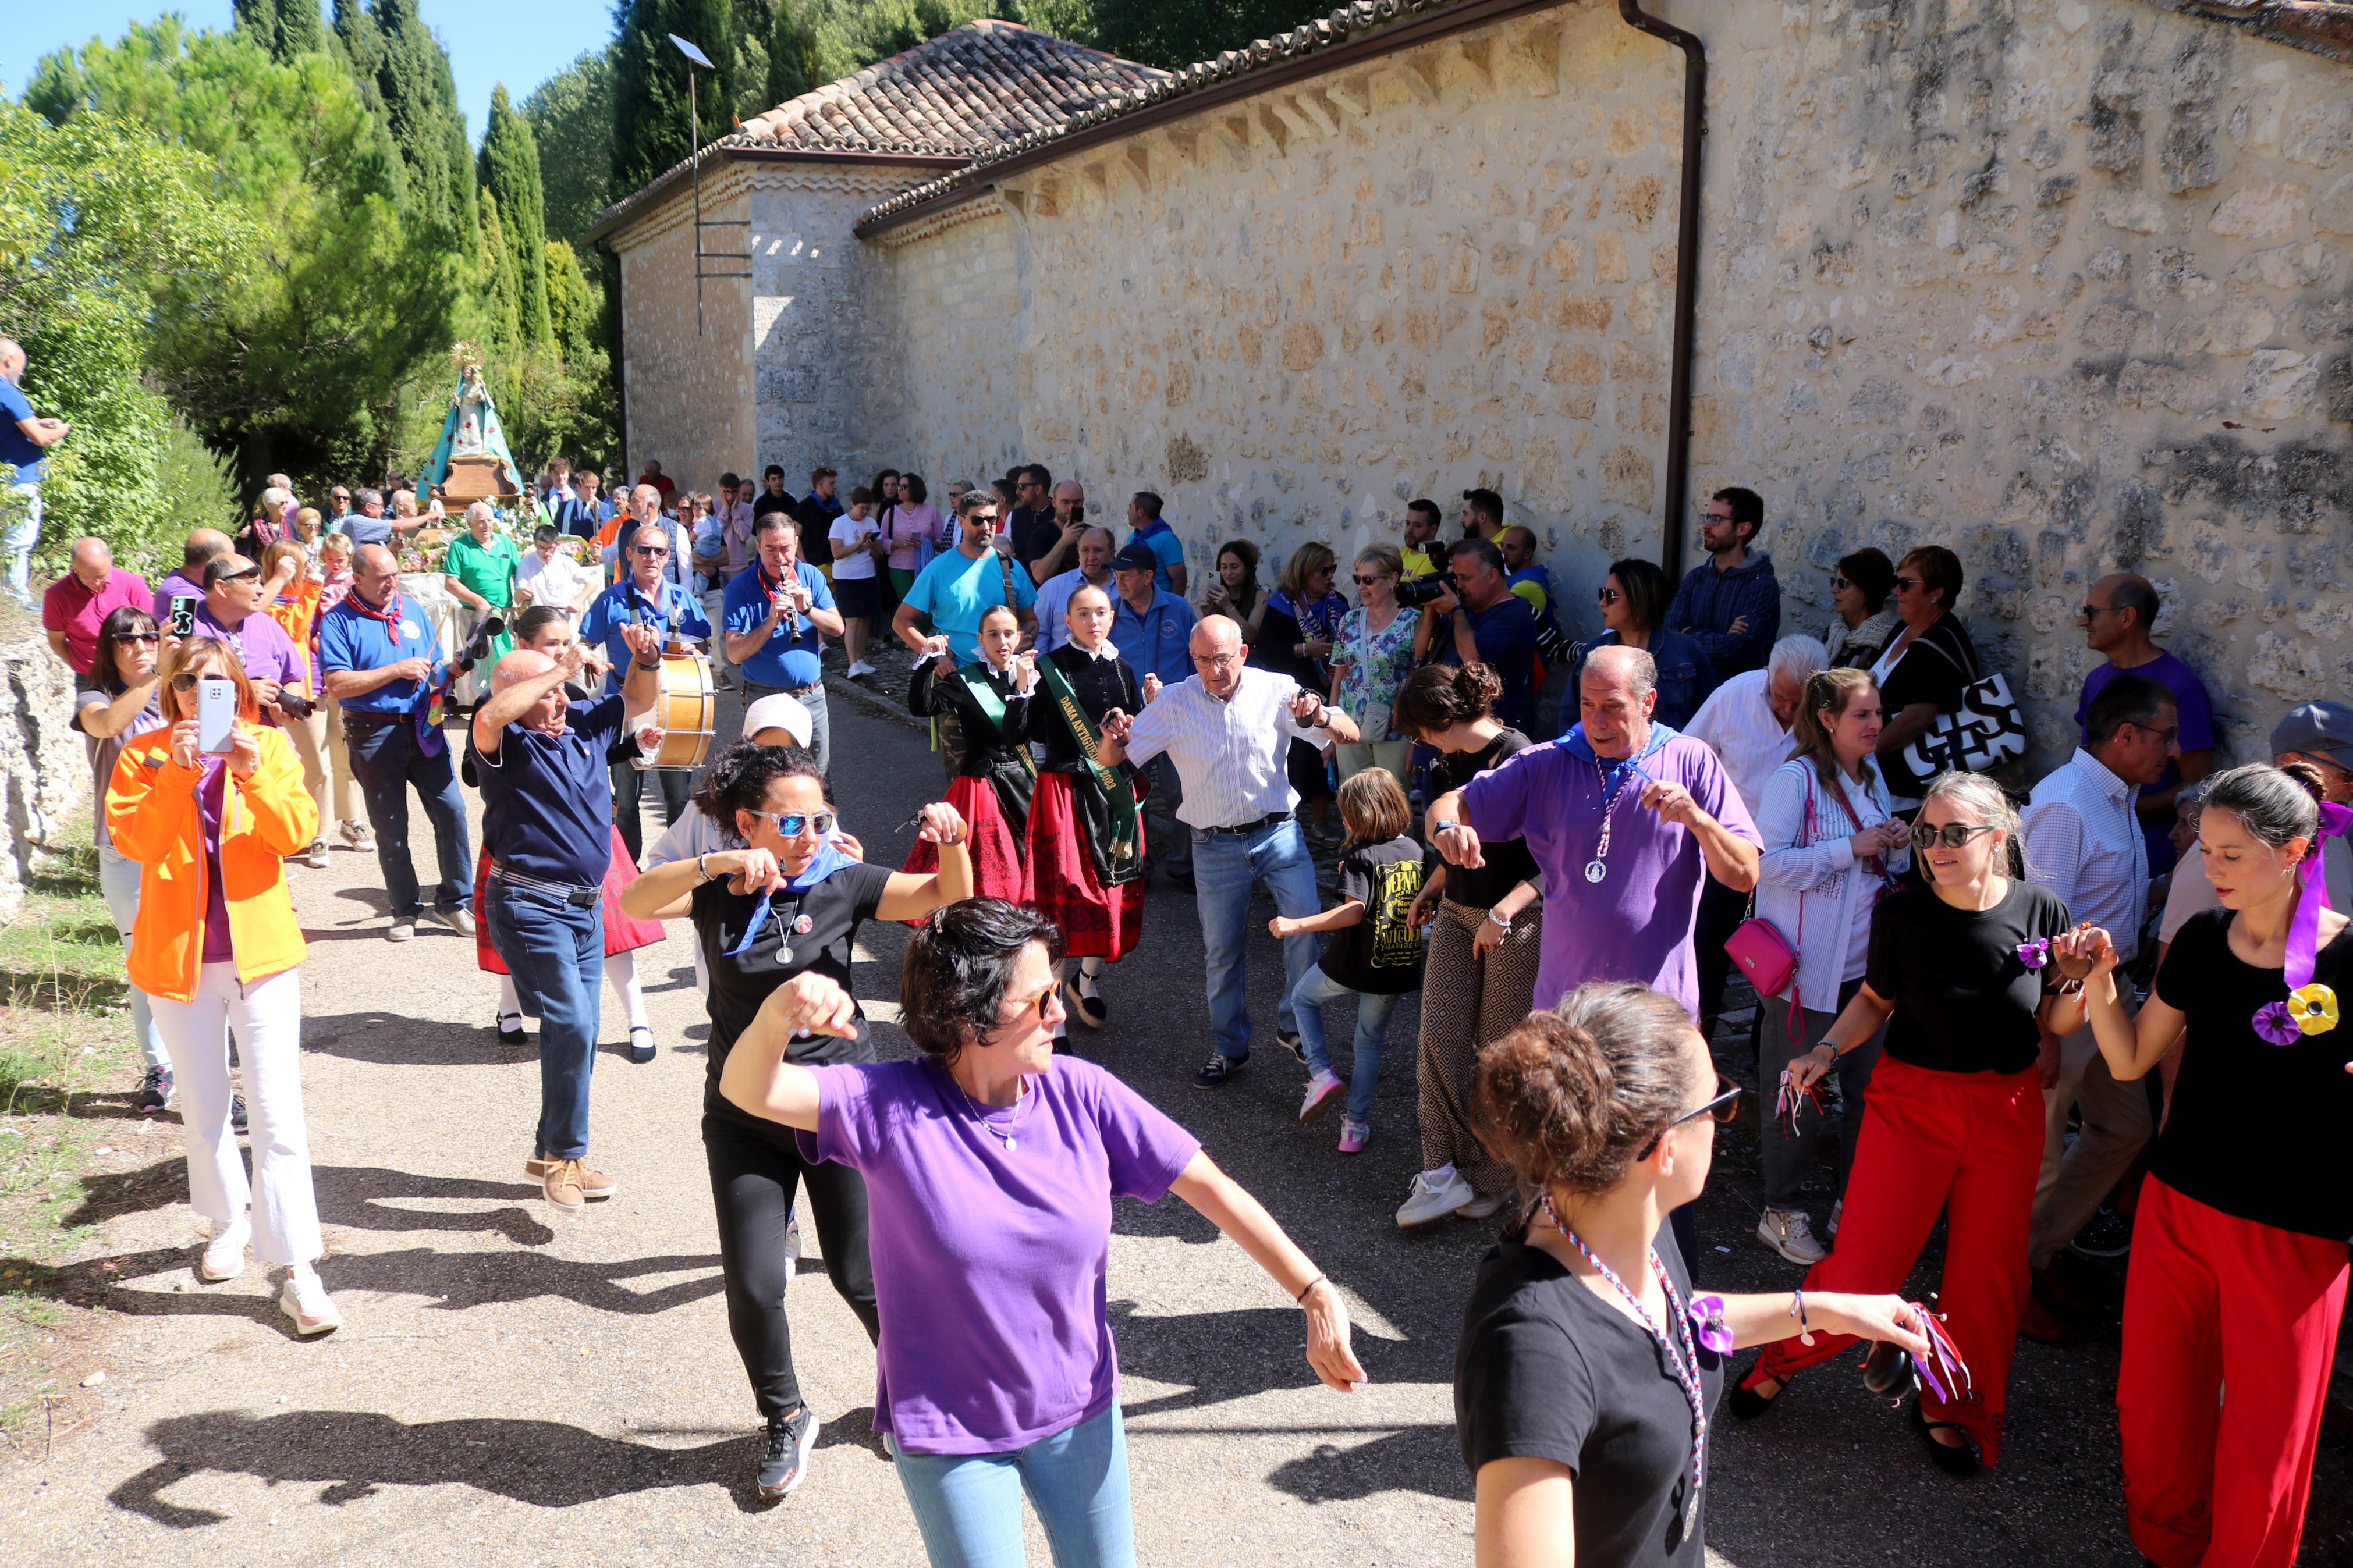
[2127,1175,2346,1568]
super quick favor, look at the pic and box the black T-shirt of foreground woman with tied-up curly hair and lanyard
[1454,1229,1725,1568]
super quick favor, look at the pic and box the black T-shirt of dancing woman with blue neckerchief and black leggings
[692,863,889,1093]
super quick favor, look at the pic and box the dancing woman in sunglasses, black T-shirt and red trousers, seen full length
[1732,773,2092,1476]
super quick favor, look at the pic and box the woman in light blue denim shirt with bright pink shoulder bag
[1755,667,1911,1265]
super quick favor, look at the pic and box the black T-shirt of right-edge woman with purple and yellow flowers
[2155,910,2353,1241]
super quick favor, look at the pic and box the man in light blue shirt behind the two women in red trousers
[2019,675,2181,1345]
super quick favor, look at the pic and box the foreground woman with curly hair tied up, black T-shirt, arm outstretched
[1454,980,1929,1568]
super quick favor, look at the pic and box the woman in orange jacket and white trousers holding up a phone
[106,637,343,1335]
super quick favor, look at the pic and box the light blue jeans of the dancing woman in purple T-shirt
[894,1403,1137,1568]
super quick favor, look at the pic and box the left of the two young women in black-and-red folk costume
[901,604,1038,903]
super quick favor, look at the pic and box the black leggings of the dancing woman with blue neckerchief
[704,1110,882,1420]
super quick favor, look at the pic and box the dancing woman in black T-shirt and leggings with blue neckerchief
[621,741,972,1500]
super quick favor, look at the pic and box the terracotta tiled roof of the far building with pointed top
[743,19,1167,155]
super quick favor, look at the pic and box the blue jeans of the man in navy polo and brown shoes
[482,874,605,1159]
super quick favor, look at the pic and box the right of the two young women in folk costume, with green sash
[1028,583,1144,1030]
